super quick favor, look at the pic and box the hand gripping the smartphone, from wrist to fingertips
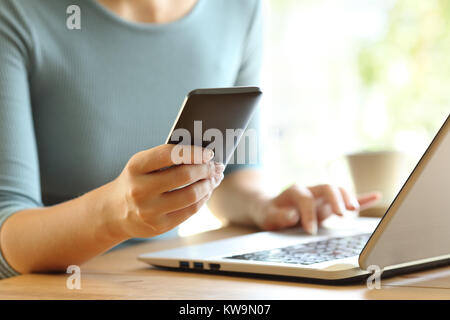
[109,144,225,238]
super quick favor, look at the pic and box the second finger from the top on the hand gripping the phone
[148,161,225,193]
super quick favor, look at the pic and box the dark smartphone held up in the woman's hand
[166,87,262,165]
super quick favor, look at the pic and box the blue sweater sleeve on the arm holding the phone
[0,1,41,279]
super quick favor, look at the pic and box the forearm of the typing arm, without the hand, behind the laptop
[208,170,269,226]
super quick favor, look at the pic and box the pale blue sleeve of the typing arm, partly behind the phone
[225,0,263,174]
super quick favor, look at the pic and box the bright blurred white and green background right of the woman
[263,0,450,192]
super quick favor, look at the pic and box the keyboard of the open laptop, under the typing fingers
[225,233,371,265]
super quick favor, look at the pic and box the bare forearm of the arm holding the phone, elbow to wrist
[0,184,126,273]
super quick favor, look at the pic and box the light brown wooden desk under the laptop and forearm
[0,227,450,299]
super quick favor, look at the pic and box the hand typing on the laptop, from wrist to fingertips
[252,185,380,234]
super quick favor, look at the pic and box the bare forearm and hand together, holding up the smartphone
[0,145,224,273]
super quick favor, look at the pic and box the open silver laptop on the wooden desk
[138,116,450,283]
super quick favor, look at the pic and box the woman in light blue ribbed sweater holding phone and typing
[0,0,377,277]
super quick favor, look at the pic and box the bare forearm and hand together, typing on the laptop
[208,170,381,234]
